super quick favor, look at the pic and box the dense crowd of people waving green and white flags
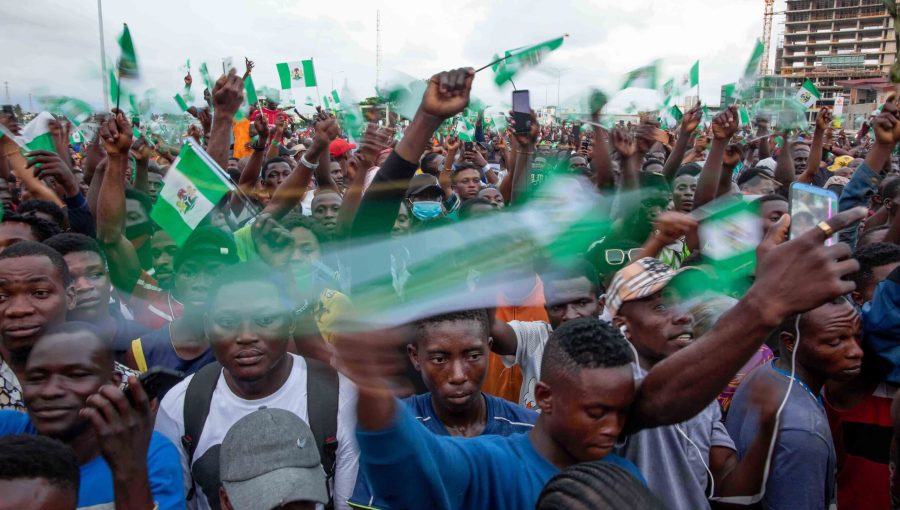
[0,55,900,510]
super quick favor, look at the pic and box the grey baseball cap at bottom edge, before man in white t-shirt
[219,408,328,510]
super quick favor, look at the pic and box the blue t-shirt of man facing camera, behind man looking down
[350,392,538,510]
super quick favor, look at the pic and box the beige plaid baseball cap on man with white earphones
[606,257,710,316]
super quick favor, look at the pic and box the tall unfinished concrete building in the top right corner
[775,0,897,122]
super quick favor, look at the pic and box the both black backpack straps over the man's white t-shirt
[181,358,338,510]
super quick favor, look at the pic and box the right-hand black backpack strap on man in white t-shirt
[306,357,339,508]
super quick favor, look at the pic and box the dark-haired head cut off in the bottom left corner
[0,434,80,510]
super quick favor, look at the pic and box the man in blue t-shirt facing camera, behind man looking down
[350,310,537,509]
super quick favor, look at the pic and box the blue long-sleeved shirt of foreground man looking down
[356,405,646,510]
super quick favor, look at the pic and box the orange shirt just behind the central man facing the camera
[481,277,550,404]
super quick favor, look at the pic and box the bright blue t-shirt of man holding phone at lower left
[0,411,185,510]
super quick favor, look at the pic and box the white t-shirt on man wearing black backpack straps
[155,354,359,509]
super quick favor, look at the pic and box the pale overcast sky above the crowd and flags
[0,0,784,113]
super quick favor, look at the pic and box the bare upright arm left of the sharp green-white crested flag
[97,112,141,292]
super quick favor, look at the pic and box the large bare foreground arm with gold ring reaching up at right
[626,208,866,430]
